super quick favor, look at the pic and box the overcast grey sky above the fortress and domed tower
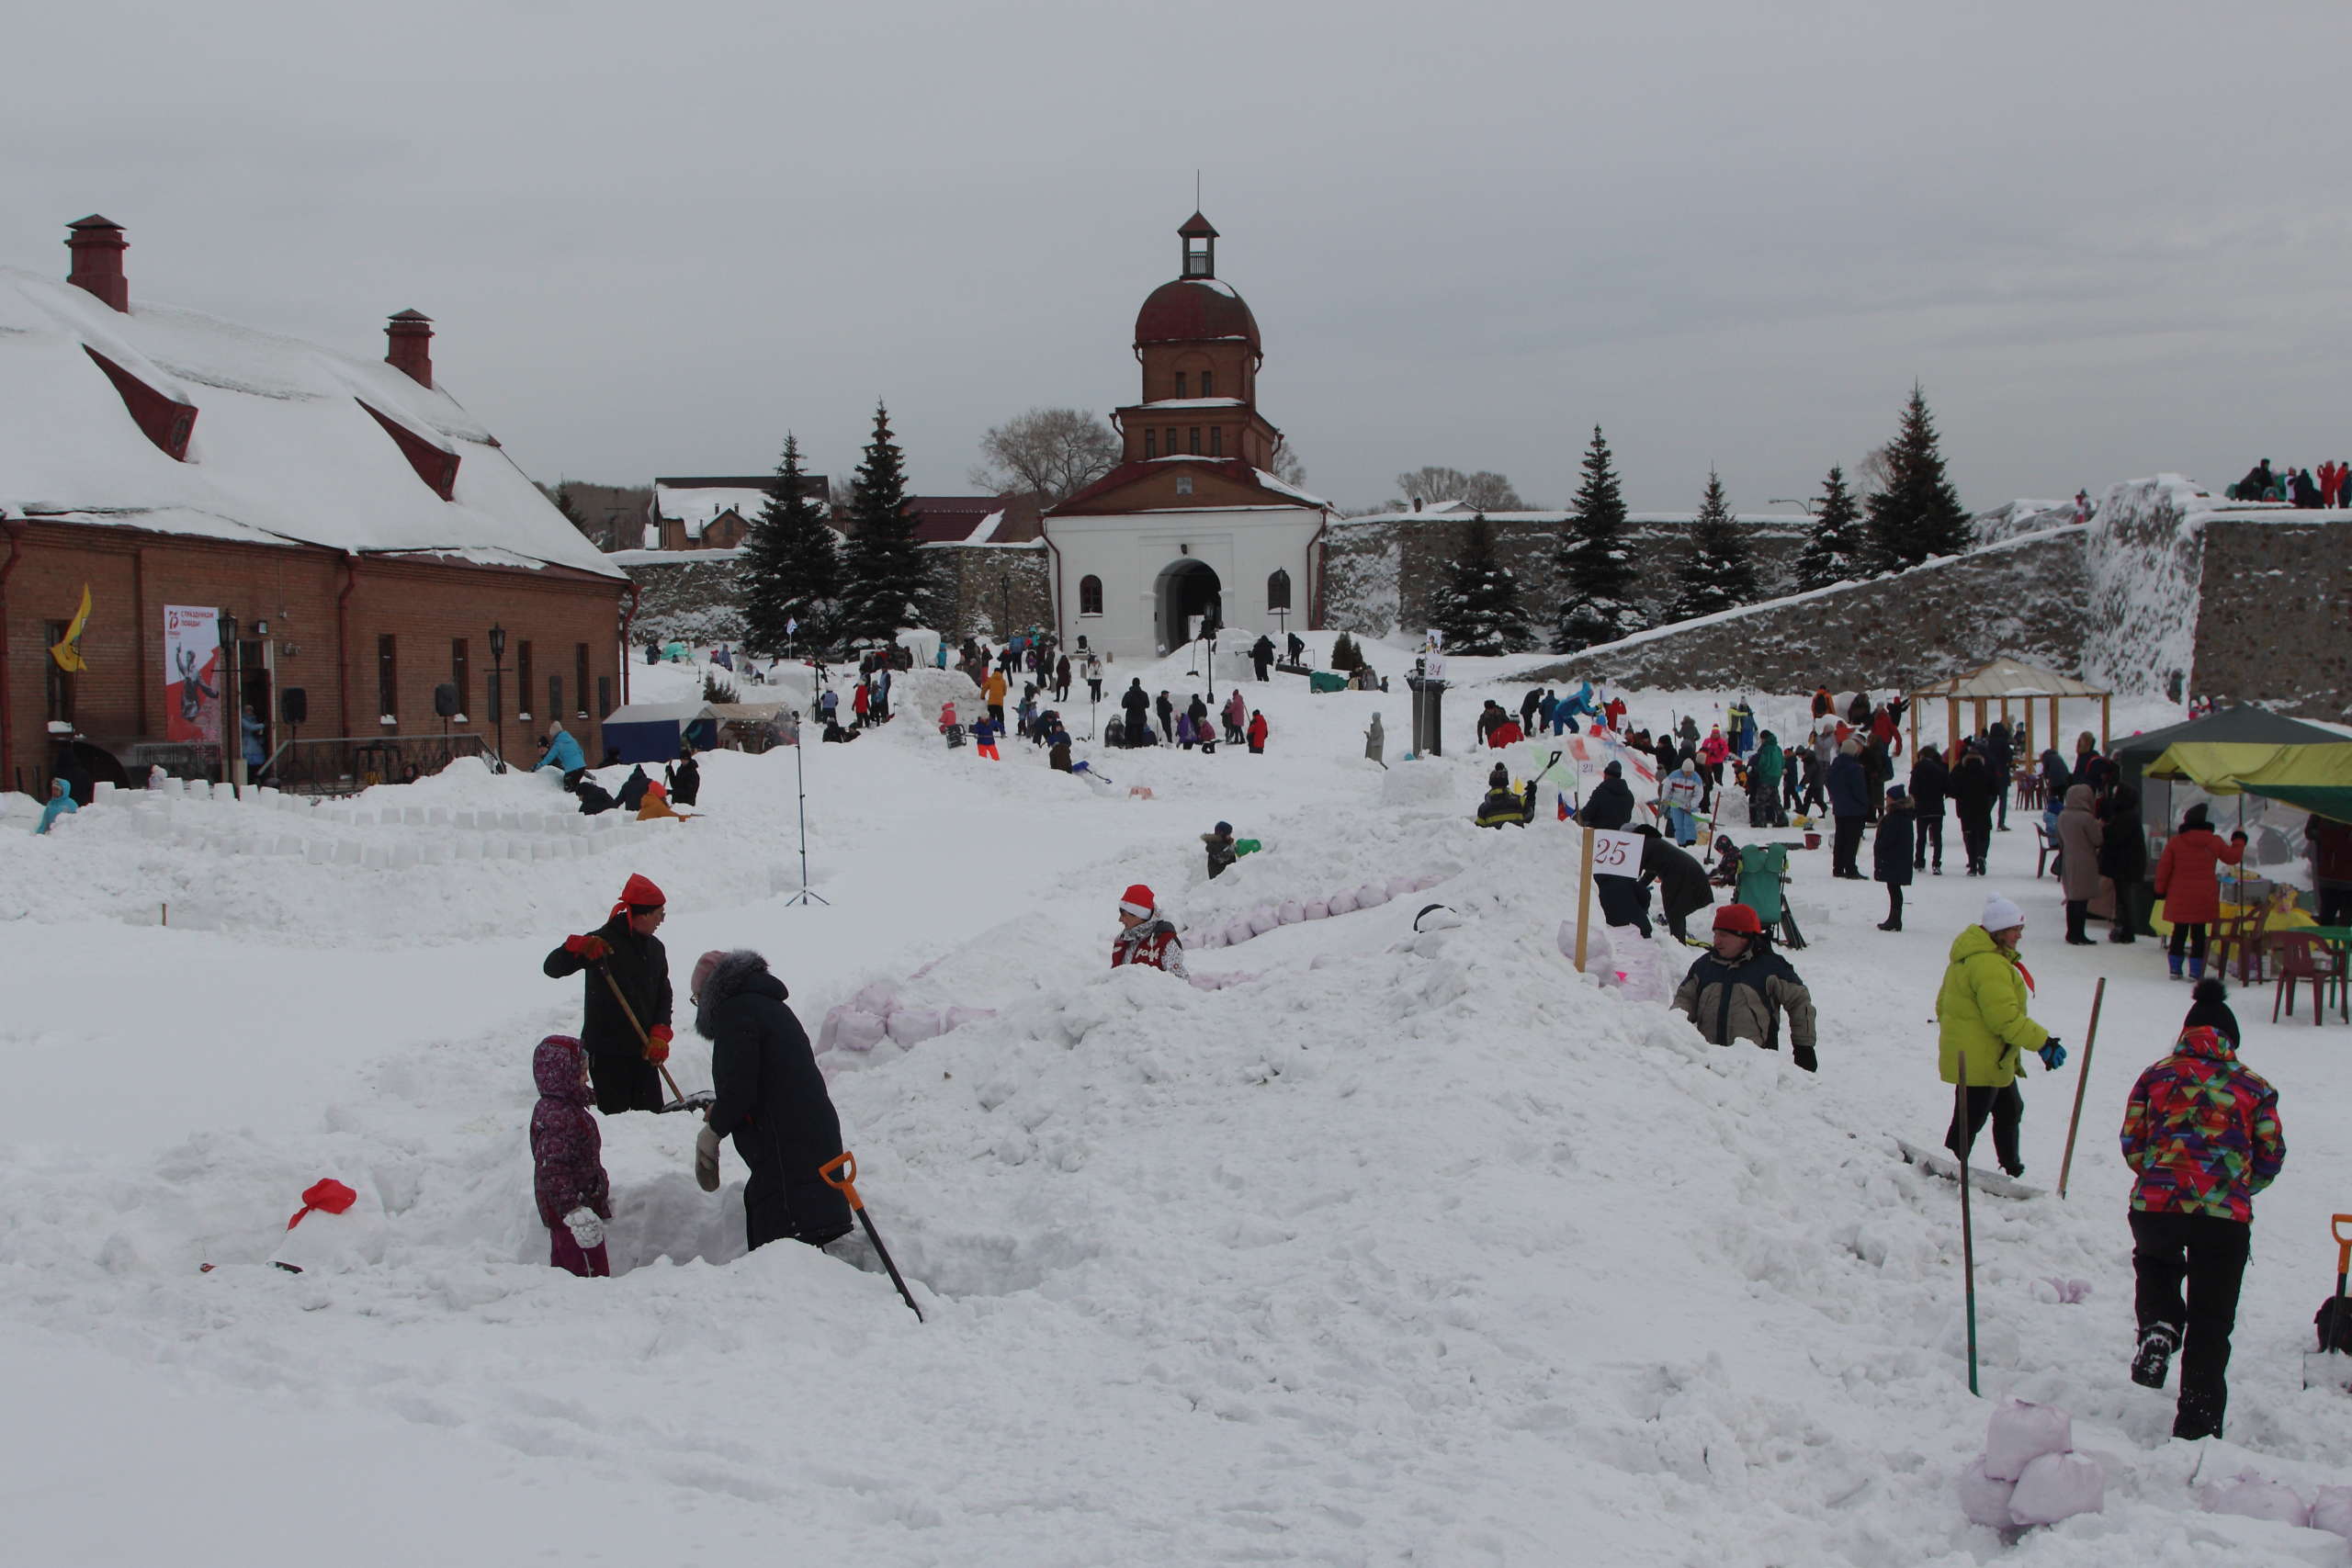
[0,0,2352,510]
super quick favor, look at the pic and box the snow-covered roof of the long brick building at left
[0,268,618,576]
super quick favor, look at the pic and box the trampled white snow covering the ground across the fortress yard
[0,639,2352,1568]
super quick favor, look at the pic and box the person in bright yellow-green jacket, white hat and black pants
[1936,894,2065,1176]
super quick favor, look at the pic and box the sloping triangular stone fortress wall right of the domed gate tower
[1526,526,2086,691]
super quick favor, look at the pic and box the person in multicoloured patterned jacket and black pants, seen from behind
[2121,1025,2286,1438]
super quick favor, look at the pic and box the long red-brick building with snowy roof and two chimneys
[0,216,633,792]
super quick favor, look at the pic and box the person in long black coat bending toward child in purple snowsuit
[694,950,849,1248]
